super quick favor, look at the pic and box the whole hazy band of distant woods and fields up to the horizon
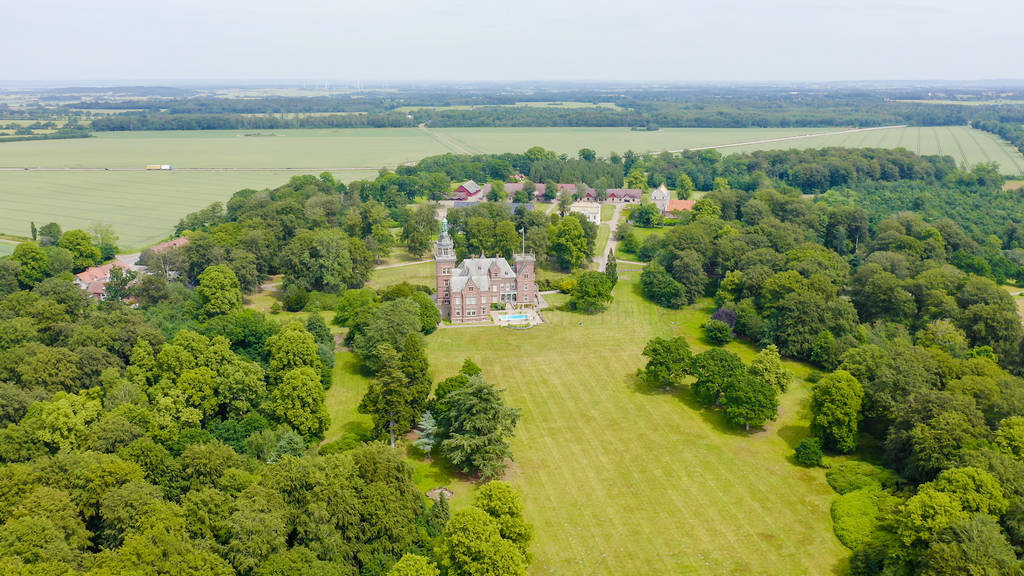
[8,85,1024,131]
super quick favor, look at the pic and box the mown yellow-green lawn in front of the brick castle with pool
[327,264,848,576]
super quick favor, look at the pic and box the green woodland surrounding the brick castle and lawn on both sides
[0,140,1024,576]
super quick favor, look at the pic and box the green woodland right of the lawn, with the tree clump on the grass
[621,142,1024,575]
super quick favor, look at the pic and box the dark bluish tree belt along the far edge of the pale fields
[83,95,1024,130]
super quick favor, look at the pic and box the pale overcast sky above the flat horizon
[0,0,1024,87]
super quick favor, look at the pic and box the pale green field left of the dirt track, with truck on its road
[0,128,450,249]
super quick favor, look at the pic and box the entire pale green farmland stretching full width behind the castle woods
[0,127,1024,250]
